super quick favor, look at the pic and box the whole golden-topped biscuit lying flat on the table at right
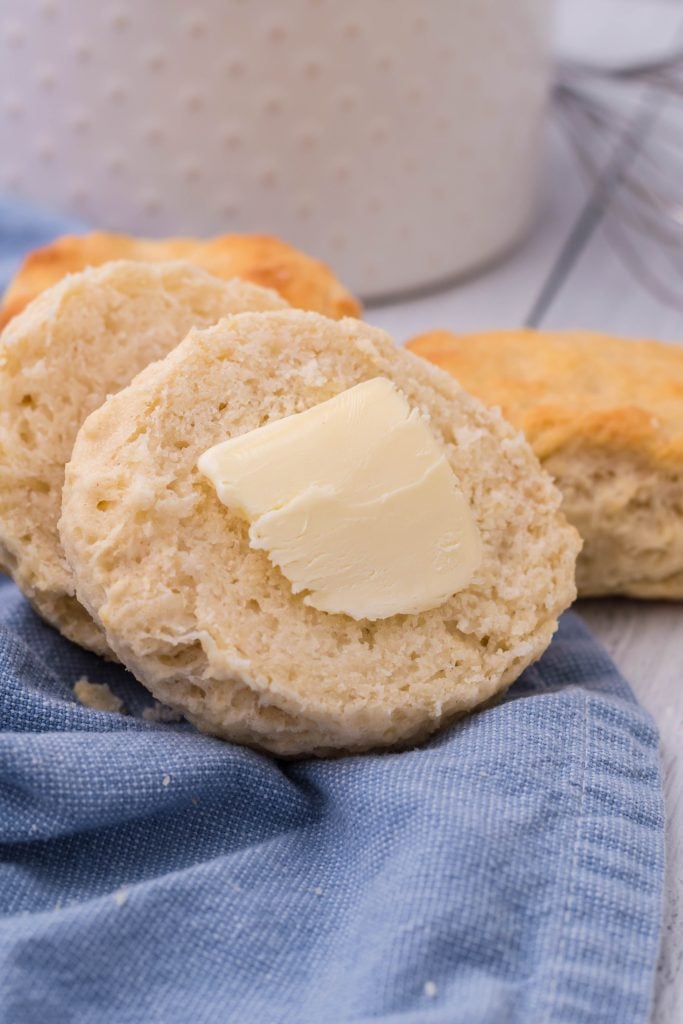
[409,331,683,599]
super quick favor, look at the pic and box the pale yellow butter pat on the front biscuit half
[198,377,481,620]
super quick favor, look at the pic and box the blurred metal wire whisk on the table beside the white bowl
[554,51,683,309]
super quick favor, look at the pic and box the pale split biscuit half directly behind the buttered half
[0,262,286,653]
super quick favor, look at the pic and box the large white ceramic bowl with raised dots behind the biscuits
[0,0,549,297]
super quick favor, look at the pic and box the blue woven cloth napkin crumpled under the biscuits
[0,199,663,1024]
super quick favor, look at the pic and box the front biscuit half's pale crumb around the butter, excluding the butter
[60,310,580,756]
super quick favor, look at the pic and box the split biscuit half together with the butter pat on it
[60,310,579,756]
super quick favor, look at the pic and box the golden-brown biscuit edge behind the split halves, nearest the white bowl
[0,231,360,328]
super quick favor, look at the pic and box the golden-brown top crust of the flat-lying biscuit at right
[408,330,683,461]
